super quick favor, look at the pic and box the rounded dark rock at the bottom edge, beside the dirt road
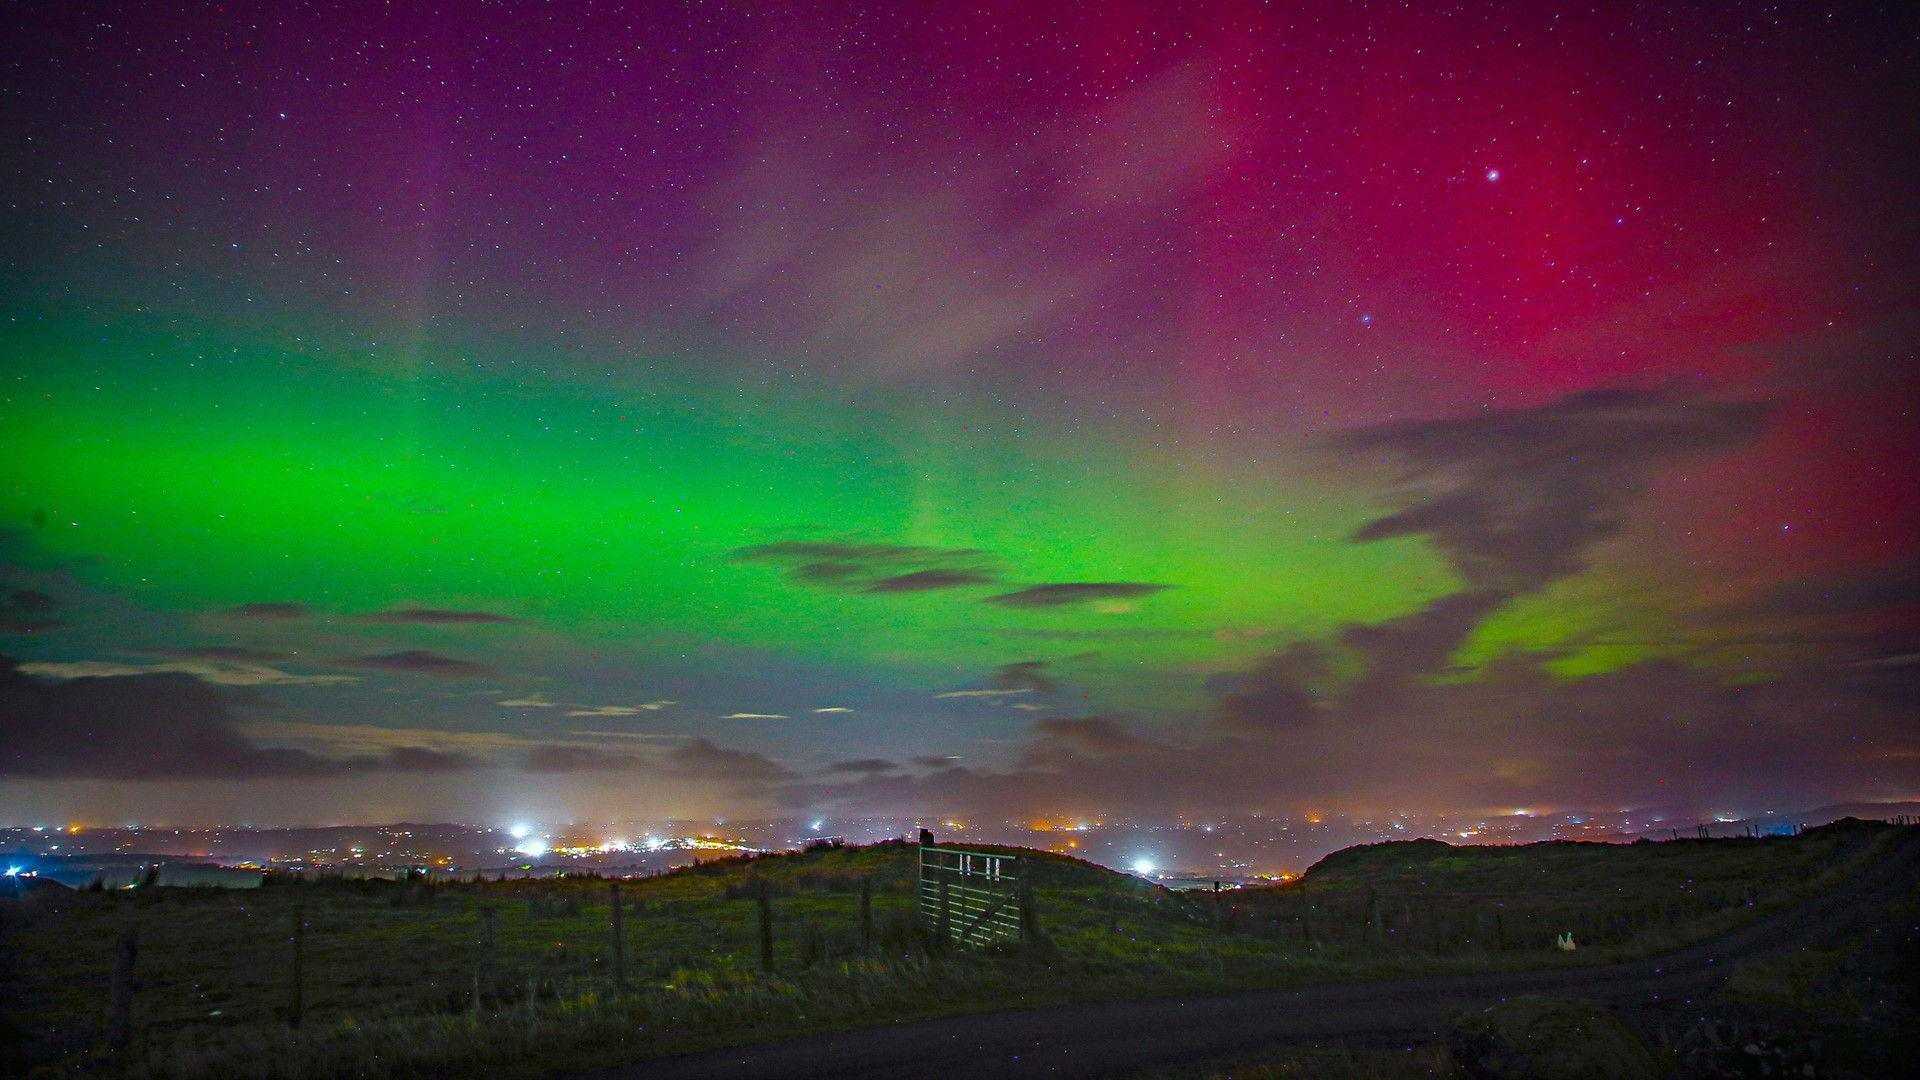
[1448,997,1661,1080]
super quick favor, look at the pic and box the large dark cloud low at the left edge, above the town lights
[0,657,476,780]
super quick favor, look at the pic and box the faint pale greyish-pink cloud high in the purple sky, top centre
[697,65,1240,380]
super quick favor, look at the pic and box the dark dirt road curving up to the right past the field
[589,834,1920,1080]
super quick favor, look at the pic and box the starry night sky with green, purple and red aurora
[0,4,1920,822]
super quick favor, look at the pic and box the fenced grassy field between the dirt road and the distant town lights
[0,824,1893,1076]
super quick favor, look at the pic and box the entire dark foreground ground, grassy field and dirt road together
[0,824,1916,1076]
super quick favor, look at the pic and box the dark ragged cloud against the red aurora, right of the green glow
[1331,390,1766,594]
